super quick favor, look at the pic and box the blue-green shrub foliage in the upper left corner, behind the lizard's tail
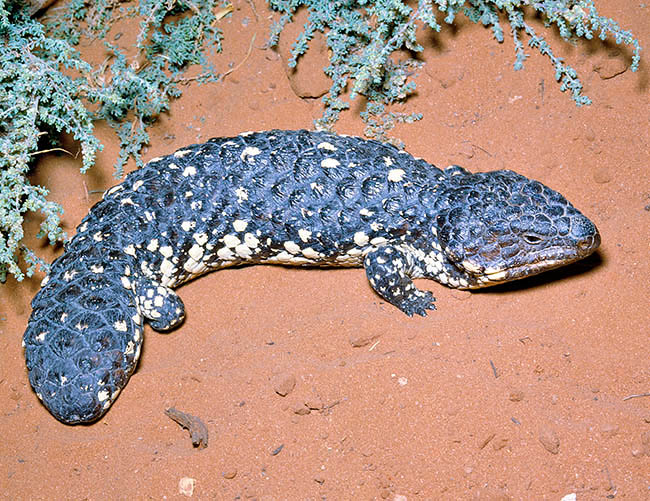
[0,0,221,281]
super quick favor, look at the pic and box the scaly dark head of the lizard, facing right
[435,166,600,289]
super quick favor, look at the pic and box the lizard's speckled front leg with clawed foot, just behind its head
[363,245,436,317]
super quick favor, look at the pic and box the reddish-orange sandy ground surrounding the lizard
[0,0,650,501]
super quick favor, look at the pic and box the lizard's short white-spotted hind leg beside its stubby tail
[134,278,185,331]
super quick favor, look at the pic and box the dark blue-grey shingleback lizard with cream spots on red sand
[23,130,600,424]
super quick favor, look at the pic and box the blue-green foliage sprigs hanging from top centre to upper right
[269,0,641,133]
